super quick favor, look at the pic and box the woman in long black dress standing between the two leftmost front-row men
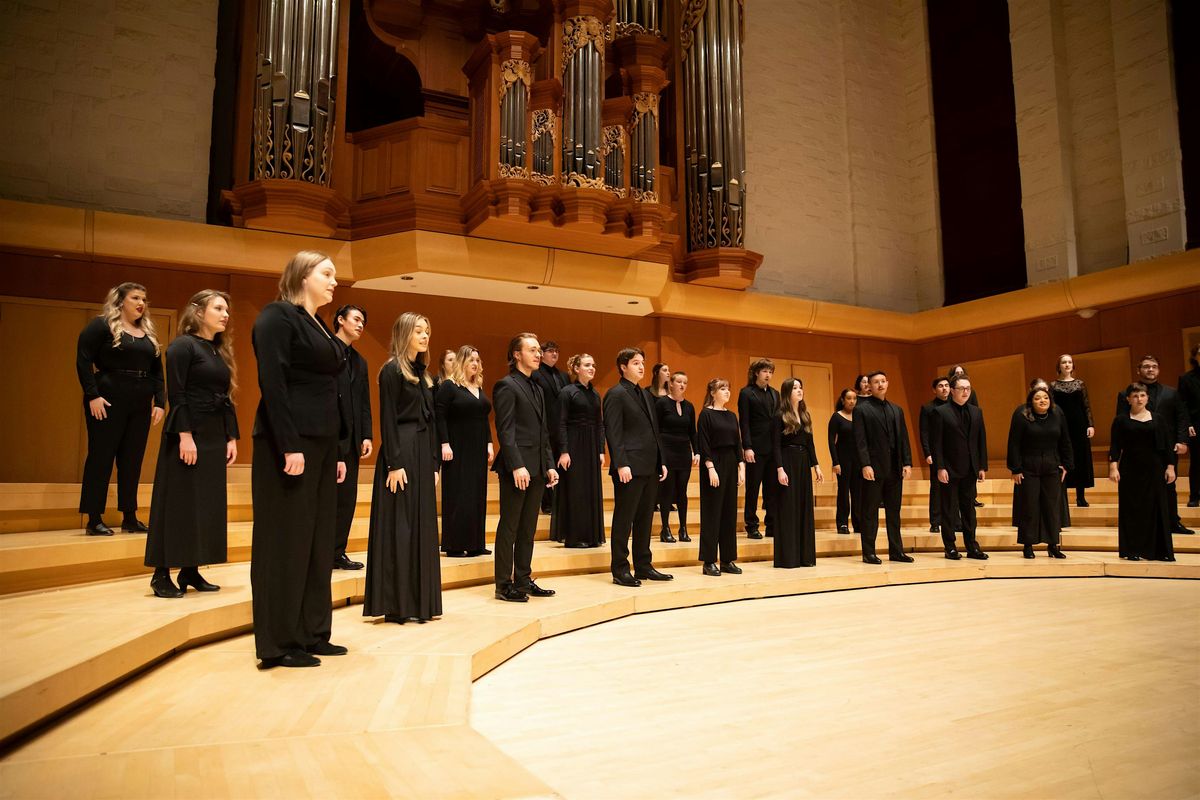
[550,353,605,547]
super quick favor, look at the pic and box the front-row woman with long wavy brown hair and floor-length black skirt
[770,378,824,569]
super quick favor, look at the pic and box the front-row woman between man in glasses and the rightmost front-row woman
[1008,386,1073,559]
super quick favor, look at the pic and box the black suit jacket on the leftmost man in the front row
[492,369,554,477]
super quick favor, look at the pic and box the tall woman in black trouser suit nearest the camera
[250,251,346,669]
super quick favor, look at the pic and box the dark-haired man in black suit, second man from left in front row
[604,348,674,587]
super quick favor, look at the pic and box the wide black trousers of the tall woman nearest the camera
[250,437,337,658]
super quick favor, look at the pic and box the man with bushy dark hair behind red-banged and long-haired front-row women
[734,359,779,539]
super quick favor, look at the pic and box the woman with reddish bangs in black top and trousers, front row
[700,378,746,576]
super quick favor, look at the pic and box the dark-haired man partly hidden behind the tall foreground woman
[334,306,372,570]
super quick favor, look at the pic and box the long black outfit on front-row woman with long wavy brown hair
[770,415,820,569]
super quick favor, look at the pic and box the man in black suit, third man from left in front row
[854,371,912,564]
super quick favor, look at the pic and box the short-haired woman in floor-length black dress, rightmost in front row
[1109,384,1176,561]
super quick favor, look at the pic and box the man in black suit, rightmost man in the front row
[931,375,988,560]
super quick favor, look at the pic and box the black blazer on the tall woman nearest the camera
[250,301,342,453]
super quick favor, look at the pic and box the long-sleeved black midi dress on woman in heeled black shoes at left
[145,335,239,567]
